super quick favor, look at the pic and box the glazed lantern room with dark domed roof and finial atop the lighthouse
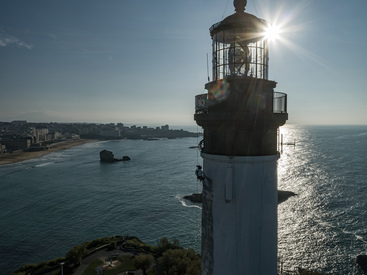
[210,1,269,81]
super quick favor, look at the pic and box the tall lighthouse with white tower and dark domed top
[194,0,288,275]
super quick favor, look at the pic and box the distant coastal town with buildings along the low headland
[0,120,197,160]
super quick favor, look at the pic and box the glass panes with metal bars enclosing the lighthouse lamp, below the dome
[213,31,268,79]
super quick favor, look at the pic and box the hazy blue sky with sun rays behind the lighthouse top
[0,0,367,125]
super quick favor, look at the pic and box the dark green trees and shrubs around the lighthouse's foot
[13,236,322,275]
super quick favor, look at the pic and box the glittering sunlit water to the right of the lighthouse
[278,125,367,274]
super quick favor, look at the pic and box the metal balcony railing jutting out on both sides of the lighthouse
[195,92,287,114]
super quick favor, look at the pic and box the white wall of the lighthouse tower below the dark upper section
[202,153,278,275]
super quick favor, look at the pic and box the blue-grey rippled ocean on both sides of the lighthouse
[0,125,367,274]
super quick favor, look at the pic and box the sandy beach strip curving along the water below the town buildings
[0,139,97,166]
